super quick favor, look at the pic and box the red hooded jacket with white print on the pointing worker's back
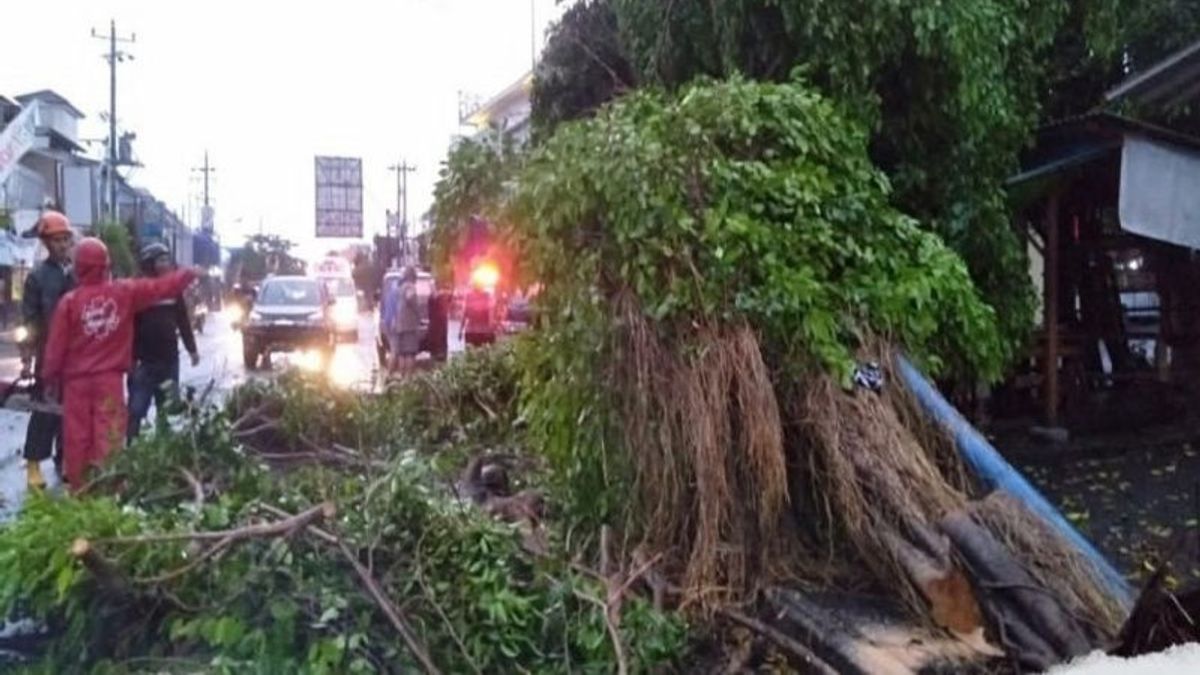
[42,258,196,381]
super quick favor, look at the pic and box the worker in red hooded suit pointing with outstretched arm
[42,237,196,490]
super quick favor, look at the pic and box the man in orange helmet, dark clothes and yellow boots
[20,211,74,490]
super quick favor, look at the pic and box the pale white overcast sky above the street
[0,0,562,253]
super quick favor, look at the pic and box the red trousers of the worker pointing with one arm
[62,372,127,492]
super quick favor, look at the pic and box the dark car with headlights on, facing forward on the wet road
[241,276,337,370]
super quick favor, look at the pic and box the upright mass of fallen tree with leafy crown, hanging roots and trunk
[498,79,1123,669]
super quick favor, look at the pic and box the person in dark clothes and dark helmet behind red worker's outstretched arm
[127,243,200,442]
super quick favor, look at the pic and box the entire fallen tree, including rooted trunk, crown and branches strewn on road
[0,80,1137,673]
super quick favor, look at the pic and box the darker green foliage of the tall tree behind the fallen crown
[580,0,1063,360]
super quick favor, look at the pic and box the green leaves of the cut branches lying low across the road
[0,357,686,674]
